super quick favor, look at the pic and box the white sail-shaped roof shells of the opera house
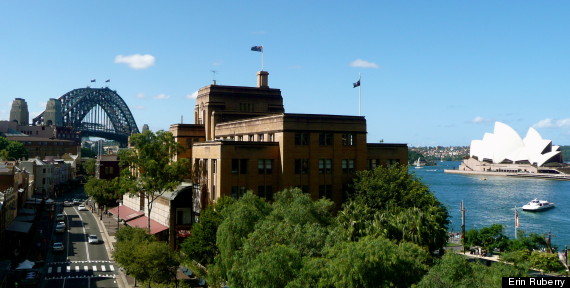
[470,122,562,166]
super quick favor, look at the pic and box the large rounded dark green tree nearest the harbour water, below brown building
[341,165,449,251]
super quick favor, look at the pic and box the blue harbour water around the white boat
[410,161,570,249]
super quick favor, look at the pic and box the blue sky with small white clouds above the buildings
[0,0,570,146]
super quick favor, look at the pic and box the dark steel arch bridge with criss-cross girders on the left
[32,87,139,147]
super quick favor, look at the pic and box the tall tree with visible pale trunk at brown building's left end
[119,130,191,230]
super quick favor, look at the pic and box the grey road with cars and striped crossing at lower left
[41,189,119,288]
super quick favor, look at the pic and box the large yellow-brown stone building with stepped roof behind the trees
[170,71,408,208]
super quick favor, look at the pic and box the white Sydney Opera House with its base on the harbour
[446,122,568,174]
